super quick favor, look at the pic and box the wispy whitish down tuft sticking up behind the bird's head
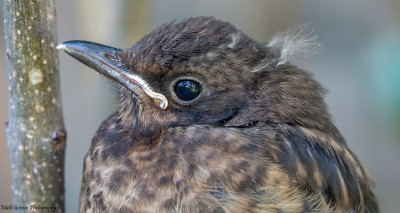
[267,24,321,66]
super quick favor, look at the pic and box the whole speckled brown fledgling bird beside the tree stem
[57,16,379,213]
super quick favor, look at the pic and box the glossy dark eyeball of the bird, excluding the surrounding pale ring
[174,80,202,101]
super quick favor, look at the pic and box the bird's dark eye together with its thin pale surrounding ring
[170,77,204,105]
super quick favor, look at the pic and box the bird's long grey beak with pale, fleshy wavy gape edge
[57,41,168,109]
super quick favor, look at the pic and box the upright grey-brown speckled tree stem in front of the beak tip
[3,0,66,212]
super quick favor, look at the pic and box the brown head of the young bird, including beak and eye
[58,17,329,136]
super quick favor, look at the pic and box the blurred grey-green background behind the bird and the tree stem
[0,0,400,212]
